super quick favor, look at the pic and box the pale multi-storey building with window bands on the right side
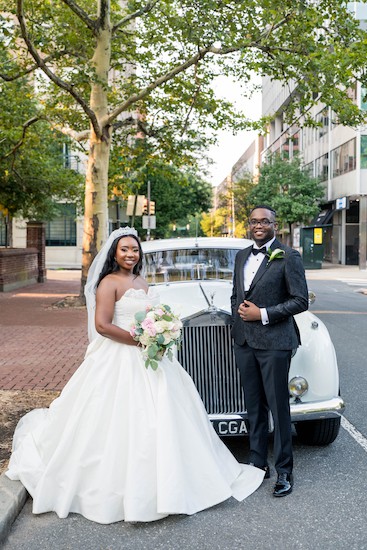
[261,2,367,269]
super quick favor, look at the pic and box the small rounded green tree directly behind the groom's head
[249,155,325,240]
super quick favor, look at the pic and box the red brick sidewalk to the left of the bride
[0,271,88,390]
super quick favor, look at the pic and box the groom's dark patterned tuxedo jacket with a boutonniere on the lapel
[231,239,308,350]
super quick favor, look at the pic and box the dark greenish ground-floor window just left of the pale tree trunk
[46,204,76,246]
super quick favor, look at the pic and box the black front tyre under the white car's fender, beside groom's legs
[295,417,341,446]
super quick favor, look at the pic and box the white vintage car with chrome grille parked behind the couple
[142,237,344,445]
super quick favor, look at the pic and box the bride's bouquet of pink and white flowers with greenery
[130,304,182,370]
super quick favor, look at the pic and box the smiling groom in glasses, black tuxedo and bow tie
[231,205,308,497]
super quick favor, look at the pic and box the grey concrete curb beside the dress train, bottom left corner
[0,474,28,543]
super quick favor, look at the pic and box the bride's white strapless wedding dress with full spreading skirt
[6,288,264,523]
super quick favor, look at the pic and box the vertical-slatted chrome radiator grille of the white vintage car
[178,325,246,414]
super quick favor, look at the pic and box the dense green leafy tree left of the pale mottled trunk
[0,51,83,245]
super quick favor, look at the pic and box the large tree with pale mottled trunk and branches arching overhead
[0,0,367,294]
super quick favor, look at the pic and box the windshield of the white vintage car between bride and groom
[144,248,239,283]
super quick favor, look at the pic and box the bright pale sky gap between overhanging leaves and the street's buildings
[208,77,261,186]
